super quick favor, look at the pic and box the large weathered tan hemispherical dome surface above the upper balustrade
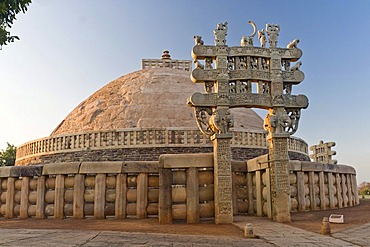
[52,68,263,135]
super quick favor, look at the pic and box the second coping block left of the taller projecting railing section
[80,161,123,174]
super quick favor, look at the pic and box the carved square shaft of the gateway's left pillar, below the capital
[213,134,233,224]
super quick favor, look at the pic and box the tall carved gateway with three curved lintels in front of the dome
[188,21,308,223]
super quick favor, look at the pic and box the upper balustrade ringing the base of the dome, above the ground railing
[16,128,308,164]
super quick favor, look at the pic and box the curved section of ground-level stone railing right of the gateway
[290,161,359,211]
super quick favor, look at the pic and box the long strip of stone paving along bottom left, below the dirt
[0,229,273,247]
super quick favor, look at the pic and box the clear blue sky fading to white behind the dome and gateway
[0,0,370,182]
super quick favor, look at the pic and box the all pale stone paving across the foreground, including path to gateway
[0,216,370,247]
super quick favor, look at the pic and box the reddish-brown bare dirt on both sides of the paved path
[0,199,370,237]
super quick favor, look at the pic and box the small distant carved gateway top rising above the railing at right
[310,140,338,164]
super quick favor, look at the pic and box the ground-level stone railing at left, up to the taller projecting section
[0,162,159,219]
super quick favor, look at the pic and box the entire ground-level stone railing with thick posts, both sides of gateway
[0,153,359,223]
